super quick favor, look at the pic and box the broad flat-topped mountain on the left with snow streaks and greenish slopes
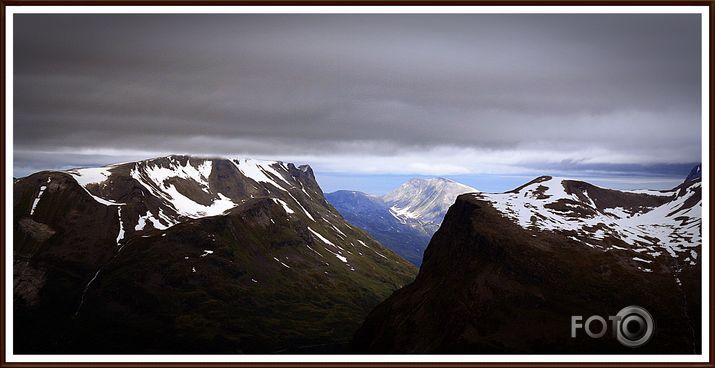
[13,156,416,354]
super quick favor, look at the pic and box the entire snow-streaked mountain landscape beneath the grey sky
[13,156,702,354]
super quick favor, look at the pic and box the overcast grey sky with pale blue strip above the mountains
[13,14,701,192]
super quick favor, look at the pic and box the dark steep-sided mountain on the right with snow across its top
[353,176,702,354]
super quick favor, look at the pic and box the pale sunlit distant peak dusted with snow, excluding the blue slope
[382,178,477,235]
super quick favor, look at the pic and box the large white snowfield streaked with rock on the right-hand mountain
[484,177,702,266]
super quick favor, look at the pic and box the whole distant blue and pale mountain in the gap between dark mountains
[326,178,477,266]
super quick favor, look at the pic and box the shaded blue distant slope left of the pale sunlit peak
[325,190,430,266]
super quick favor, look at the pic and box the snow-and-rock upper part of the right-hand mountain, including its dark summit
[474,176,702,272]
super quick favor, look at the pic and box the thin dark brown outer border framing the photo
[0,0,715,368]
